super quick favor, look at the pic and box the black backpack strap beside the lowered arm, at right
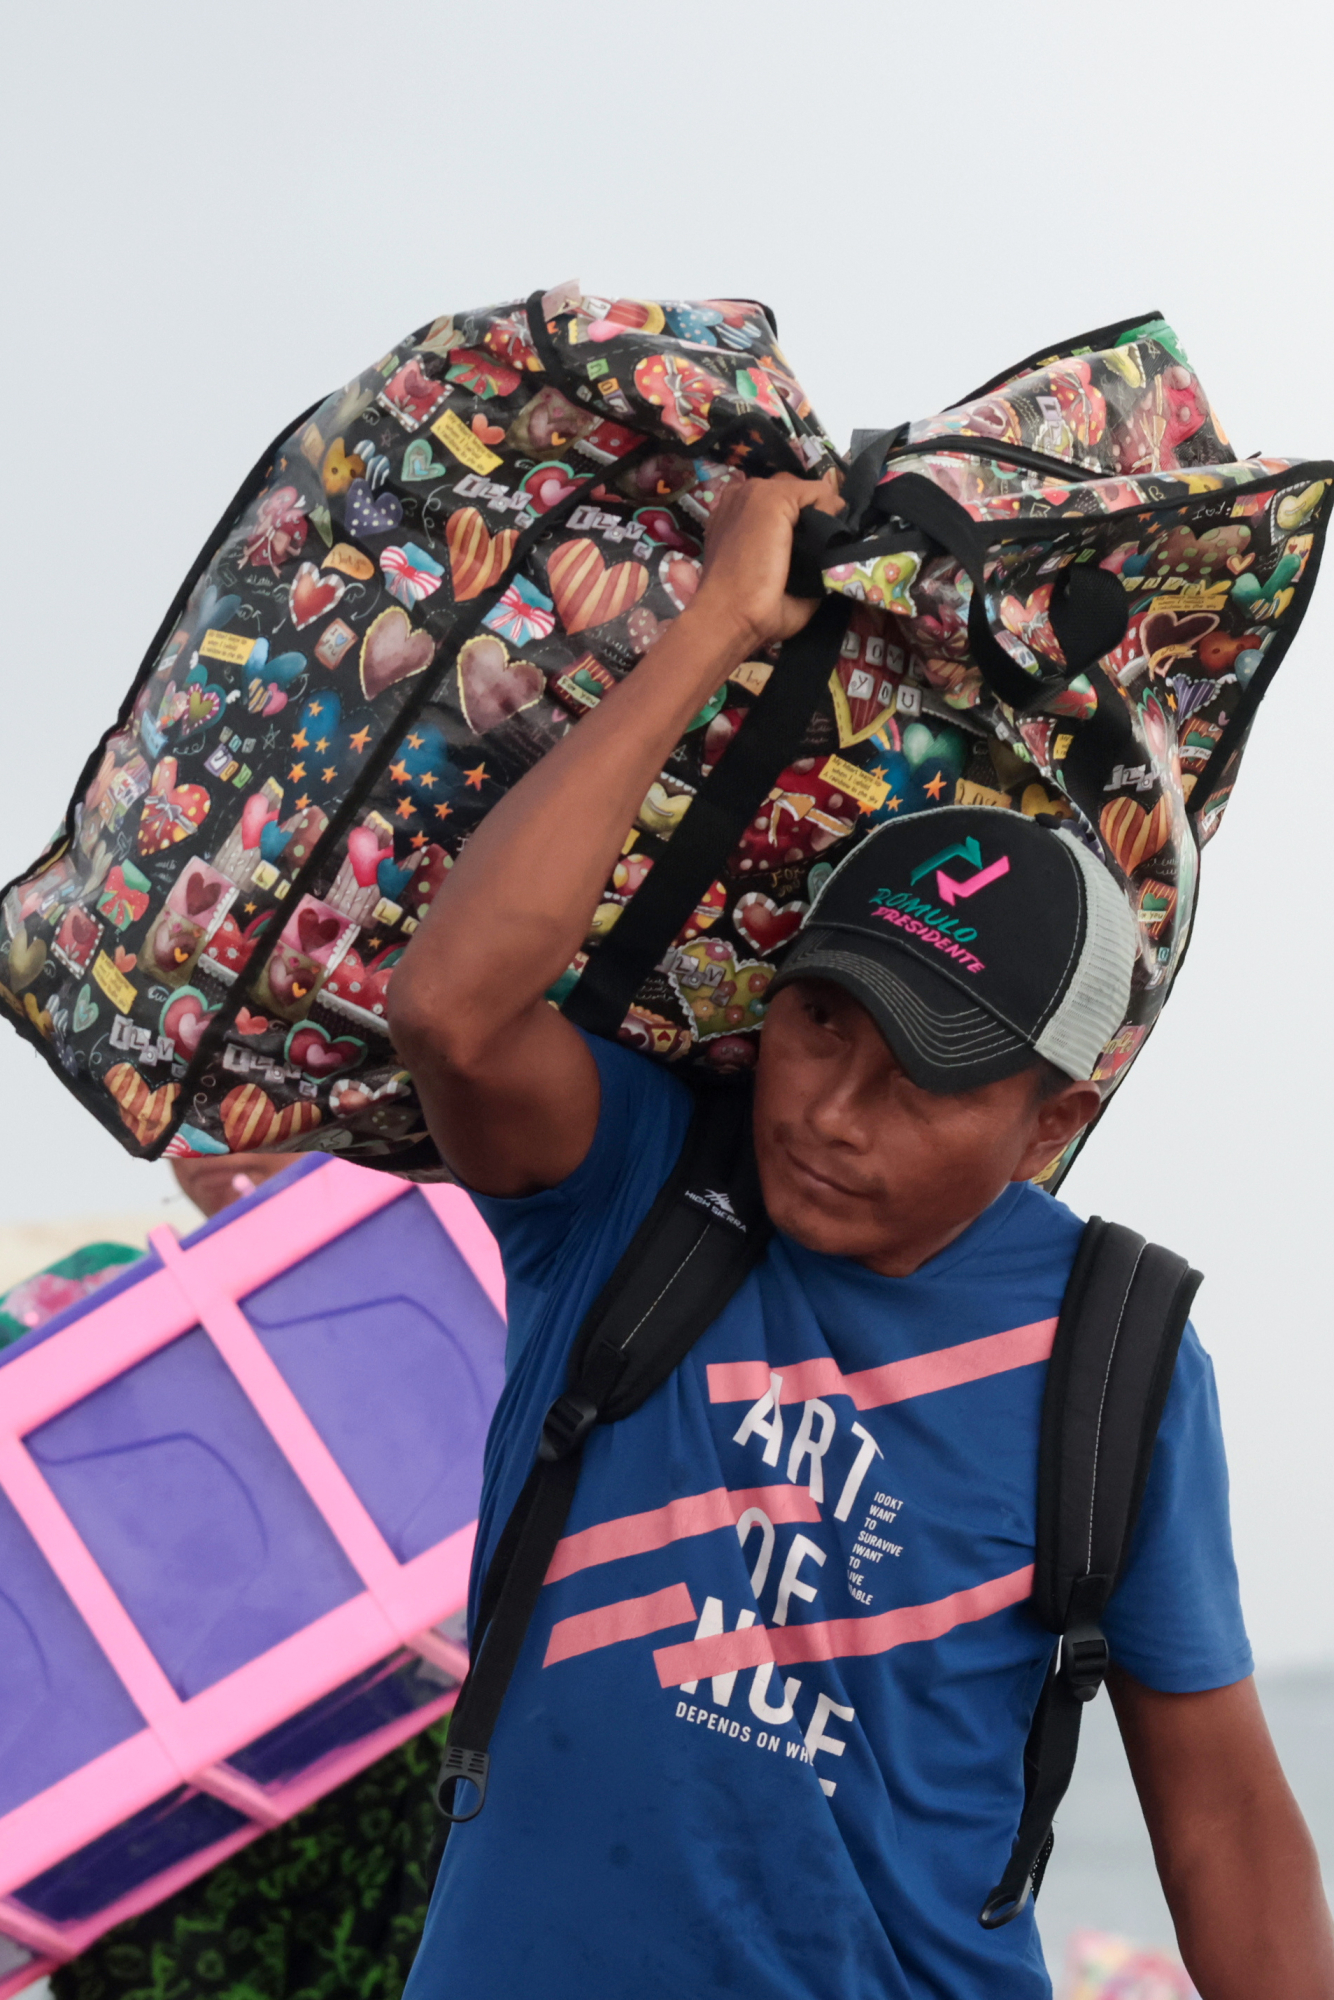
[980,1216,1200,1930]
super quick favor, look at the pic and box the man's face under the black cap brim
[754,980,1098,1276]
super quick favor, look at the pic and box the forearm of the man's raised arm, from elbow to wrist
[394,600,754,1050]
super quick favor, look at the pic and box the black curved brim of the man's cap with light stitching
[766,926,1038,1096]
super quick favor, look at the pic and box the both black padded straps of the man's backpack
[436,1086,1200,1930]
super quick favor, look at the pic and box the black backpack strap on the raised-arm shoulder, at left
[436,1084,772,1824]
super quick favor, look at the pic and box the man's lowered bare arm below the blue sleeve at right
[1108,1672,1334,2000]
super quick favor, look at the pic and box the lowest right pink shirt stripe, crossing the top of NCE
[654,1564,1032,1688]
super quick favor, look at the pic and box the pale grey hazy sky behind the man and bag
[0,0,1334,1666]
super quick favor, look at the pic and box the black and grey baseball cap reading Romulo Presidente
[770,806,1138,1092]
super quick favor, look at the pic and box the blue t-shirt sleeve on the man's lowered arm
[1104,1326,1254,1694]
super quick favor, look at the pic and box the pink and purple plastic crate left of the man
[0,1158,504,2000]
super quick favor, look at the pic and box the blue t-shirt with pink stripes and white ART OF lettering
[406,1042,1252,2000]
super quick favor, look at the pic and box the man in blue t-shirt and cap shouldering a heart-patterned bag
[392,476,1334,2000]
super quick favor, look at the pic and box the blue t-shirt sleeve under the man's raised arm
[472,1034,692,1366]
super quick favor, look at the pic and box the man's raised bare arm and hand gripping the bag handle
[390,474,840,1194]
